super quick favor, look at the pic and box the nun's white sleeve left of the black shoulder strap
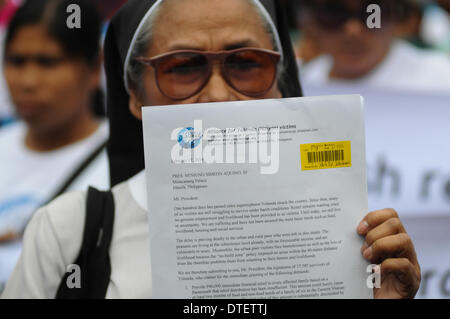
[1,192,85,298]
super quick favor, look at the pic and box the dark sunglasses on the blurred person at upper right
[313,0,399,30]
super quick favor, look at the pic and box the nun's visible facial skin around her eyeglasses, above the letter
[130,0,281,118]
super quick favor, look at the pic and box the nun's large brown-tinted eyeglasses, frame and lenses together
[136,48,281,100]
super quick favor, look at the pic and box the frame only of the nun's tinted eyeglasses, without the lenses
[135,47,281,100]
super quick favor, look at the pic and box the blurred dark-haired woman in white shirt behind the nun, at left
[0,0,109,292]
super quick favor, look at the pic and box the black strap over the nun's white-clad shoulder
[56,187,114,299]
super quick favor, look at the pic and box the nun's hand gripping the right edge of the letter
[357,209,420,298]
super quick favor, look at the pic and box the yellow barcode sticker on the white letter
[300,141,352,171]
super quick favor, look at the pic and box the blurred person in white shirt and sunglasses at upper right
[301,0,450,94]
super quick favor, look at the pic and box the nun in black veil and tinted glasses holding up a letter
[3,0,420,298]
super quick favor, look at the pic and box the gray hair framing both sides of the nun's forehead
[126,0,286,94]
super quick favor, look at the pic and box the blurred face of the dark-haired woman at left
[4,25,99,131]
